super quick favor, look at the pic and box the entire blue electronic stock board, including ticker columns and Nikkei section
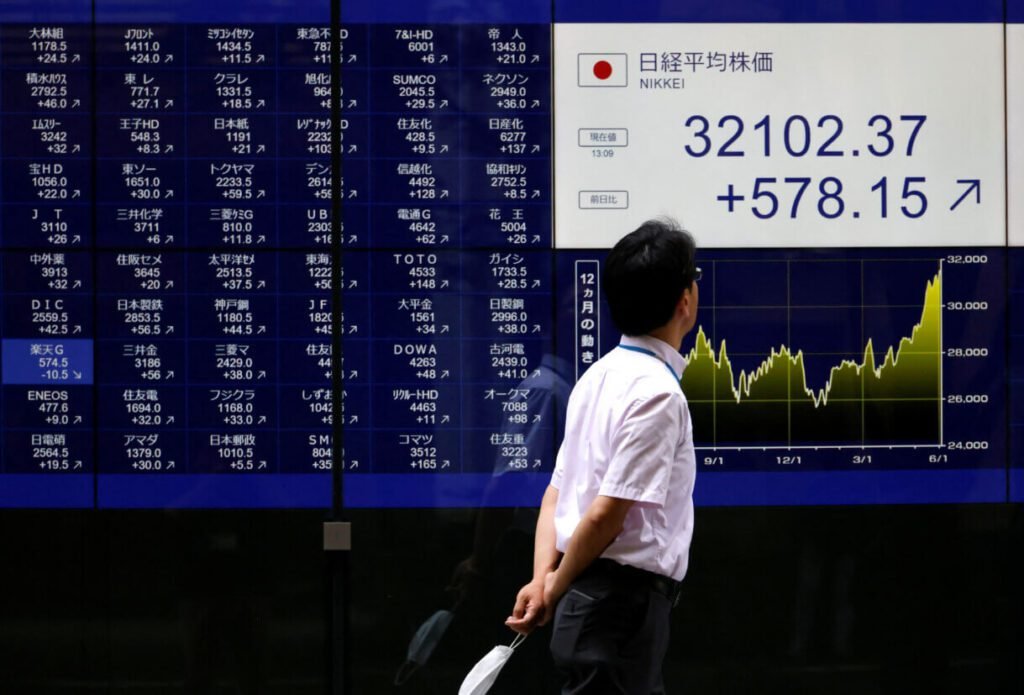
[0,0,1024,508]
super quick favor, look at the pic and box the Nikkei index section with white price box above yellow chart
[555,3,1008,505]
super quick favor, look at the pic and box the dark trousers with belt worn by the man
[551,560,672,695]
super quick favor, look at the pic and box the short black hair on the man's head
[601,219,696,336]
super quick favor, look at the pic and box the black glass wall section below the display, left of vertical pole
[0,511,329,694]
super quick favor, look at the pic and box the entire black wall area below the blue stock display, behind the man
[0,505,1024,695]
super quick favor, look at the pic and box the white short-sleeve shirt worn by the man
[551,336,696,580]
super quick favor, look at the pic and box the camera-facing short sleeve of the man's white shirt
[598,392,683,507]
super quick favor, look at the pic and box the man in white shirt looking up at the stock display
[506,220,700,695]
